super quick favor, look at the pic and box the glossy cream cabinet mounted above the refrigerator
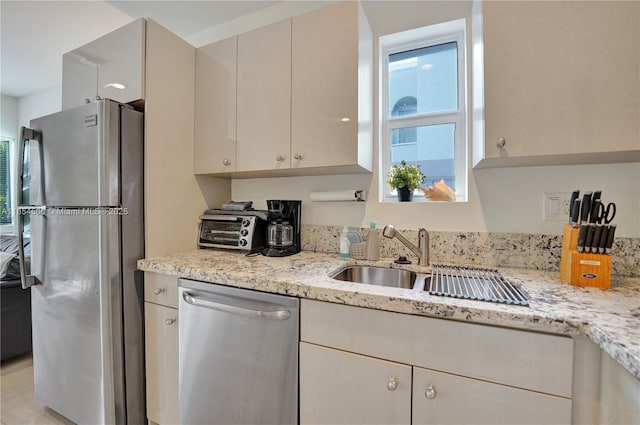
[62,19,146,110]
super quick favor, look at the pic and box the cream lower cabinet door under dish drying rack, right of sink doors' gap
[412,367,571,425]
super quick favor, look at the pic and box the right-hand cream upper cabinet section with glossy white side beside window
[291,1,373,172]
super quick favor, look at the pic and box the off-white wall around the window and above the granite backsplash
[226,1,640,237]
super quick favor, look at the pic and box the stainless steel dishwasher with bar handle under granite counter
[178,279,300,425]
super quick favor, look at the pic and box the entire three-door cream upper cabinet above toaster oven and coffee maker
[194,1,373,178]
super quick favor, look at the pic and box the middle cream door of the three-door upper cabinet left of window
[236,19,291,171]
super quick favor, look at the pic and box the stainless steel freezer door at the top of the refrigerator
[23,100,120,206]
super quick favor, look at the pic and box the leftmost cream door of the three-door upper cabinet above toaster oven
[193,37,238,174]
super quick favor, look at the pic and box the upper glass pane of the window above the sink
[389,42,458,117]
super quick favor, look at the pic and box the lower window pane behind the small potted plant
[391,123,456,190]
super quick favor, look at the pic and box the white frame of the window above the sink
[379,18,468,202]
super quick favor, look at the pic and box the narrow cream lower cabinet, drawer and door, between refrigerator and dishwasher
[144,272,179,425]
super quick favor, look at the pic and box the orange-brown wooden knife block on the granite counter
[560,224,611,289]
